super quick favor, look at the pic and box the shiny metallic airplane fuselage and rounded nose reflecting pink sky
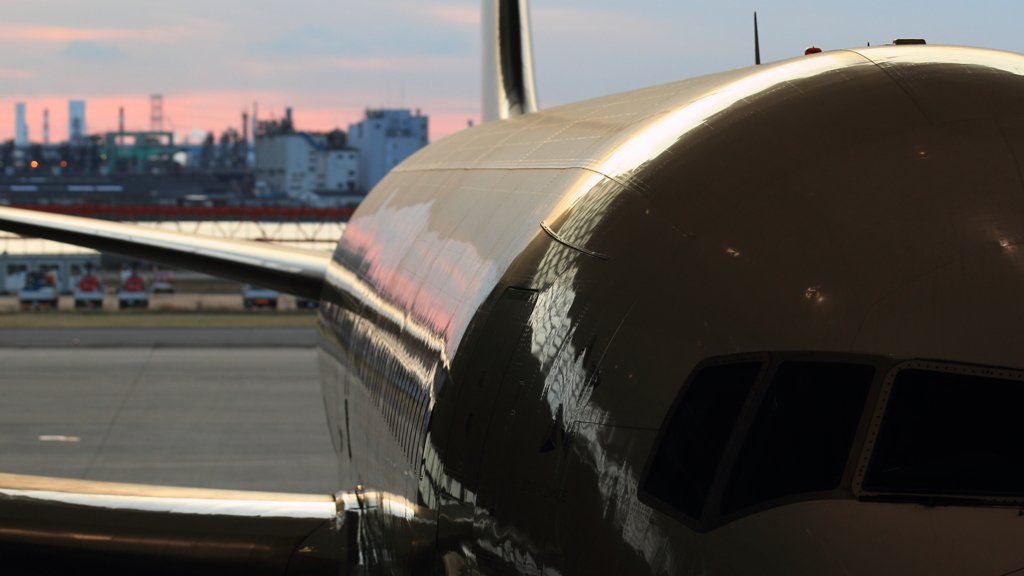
[319,46,1024,576]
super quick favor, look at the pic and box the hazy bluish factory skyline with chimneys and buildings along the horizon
[0,100,428,206]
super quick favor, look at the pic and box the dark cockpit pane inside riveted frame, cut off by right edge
[862,369,1024,498]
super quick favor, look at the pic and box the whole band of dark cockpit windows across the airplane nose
[639,352,1024,531]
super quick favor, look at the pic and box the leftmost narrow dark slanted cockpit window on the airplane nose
[644,362,762,521]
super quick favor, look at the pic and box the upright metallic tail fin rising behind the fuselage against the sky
[481,0,537,122]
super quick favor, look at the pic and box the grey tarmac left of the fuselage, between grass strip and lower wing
[0,328,340,494]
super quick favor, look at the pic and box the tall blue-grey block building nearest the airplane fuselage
[348,110,427,193]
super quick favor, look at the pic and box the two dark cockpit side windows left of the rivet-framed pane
[641,353,876,529]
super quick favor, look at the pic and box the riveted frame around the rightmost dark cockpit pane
[852,360,1024,505]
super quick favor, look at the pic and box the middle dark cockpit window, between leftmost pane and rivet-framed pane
[720,362,874,515]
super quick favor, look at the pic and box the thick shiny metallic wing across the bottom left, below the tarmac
[0,474,358,575]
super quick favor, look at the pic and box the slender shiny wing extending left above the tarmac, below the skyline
[0,207,331,299]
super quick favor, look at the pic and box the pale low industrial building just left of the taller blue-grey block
[255,109,359,198]
